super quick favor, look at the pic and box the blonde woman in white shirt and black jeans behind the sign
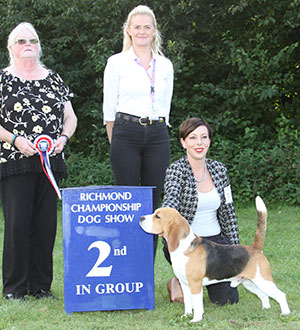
[103,6,173,255]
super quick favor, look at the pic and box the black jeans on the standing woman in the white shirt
[110,118,170,252]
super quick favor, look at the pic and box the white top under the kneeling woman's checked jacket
[191,187,221,237]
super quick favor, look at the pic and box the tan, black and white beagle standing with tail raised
[140,196,290,322]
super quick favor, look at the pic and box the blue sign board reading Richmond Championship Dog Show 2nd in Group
[62,186,154,314]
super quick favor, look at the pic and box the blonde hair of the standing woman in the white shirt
[123,5,162,55]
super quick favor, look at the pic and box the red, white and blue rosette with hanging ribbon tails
[34,134,61,199]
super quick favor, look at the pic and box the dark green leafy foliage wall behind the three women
[0,0,300,204]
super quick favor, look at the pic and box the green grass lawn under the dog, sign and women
[0,203,300,330]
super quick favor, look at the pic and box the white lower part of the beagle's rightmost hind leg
[253,277,291,315]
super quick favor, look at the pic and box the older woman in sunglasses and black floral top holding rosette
[0,23,77,299]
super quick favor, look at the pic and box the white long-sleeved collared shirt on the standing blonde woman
[103,47,174,124]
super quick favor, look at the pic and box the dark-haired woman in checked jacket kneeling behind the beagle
[162,118,239,305]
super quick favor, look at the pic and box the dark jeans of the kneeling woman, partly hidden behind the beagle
[163,234,239,305]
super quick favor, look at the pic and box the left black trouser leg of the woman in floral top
[0,174,35,295]
